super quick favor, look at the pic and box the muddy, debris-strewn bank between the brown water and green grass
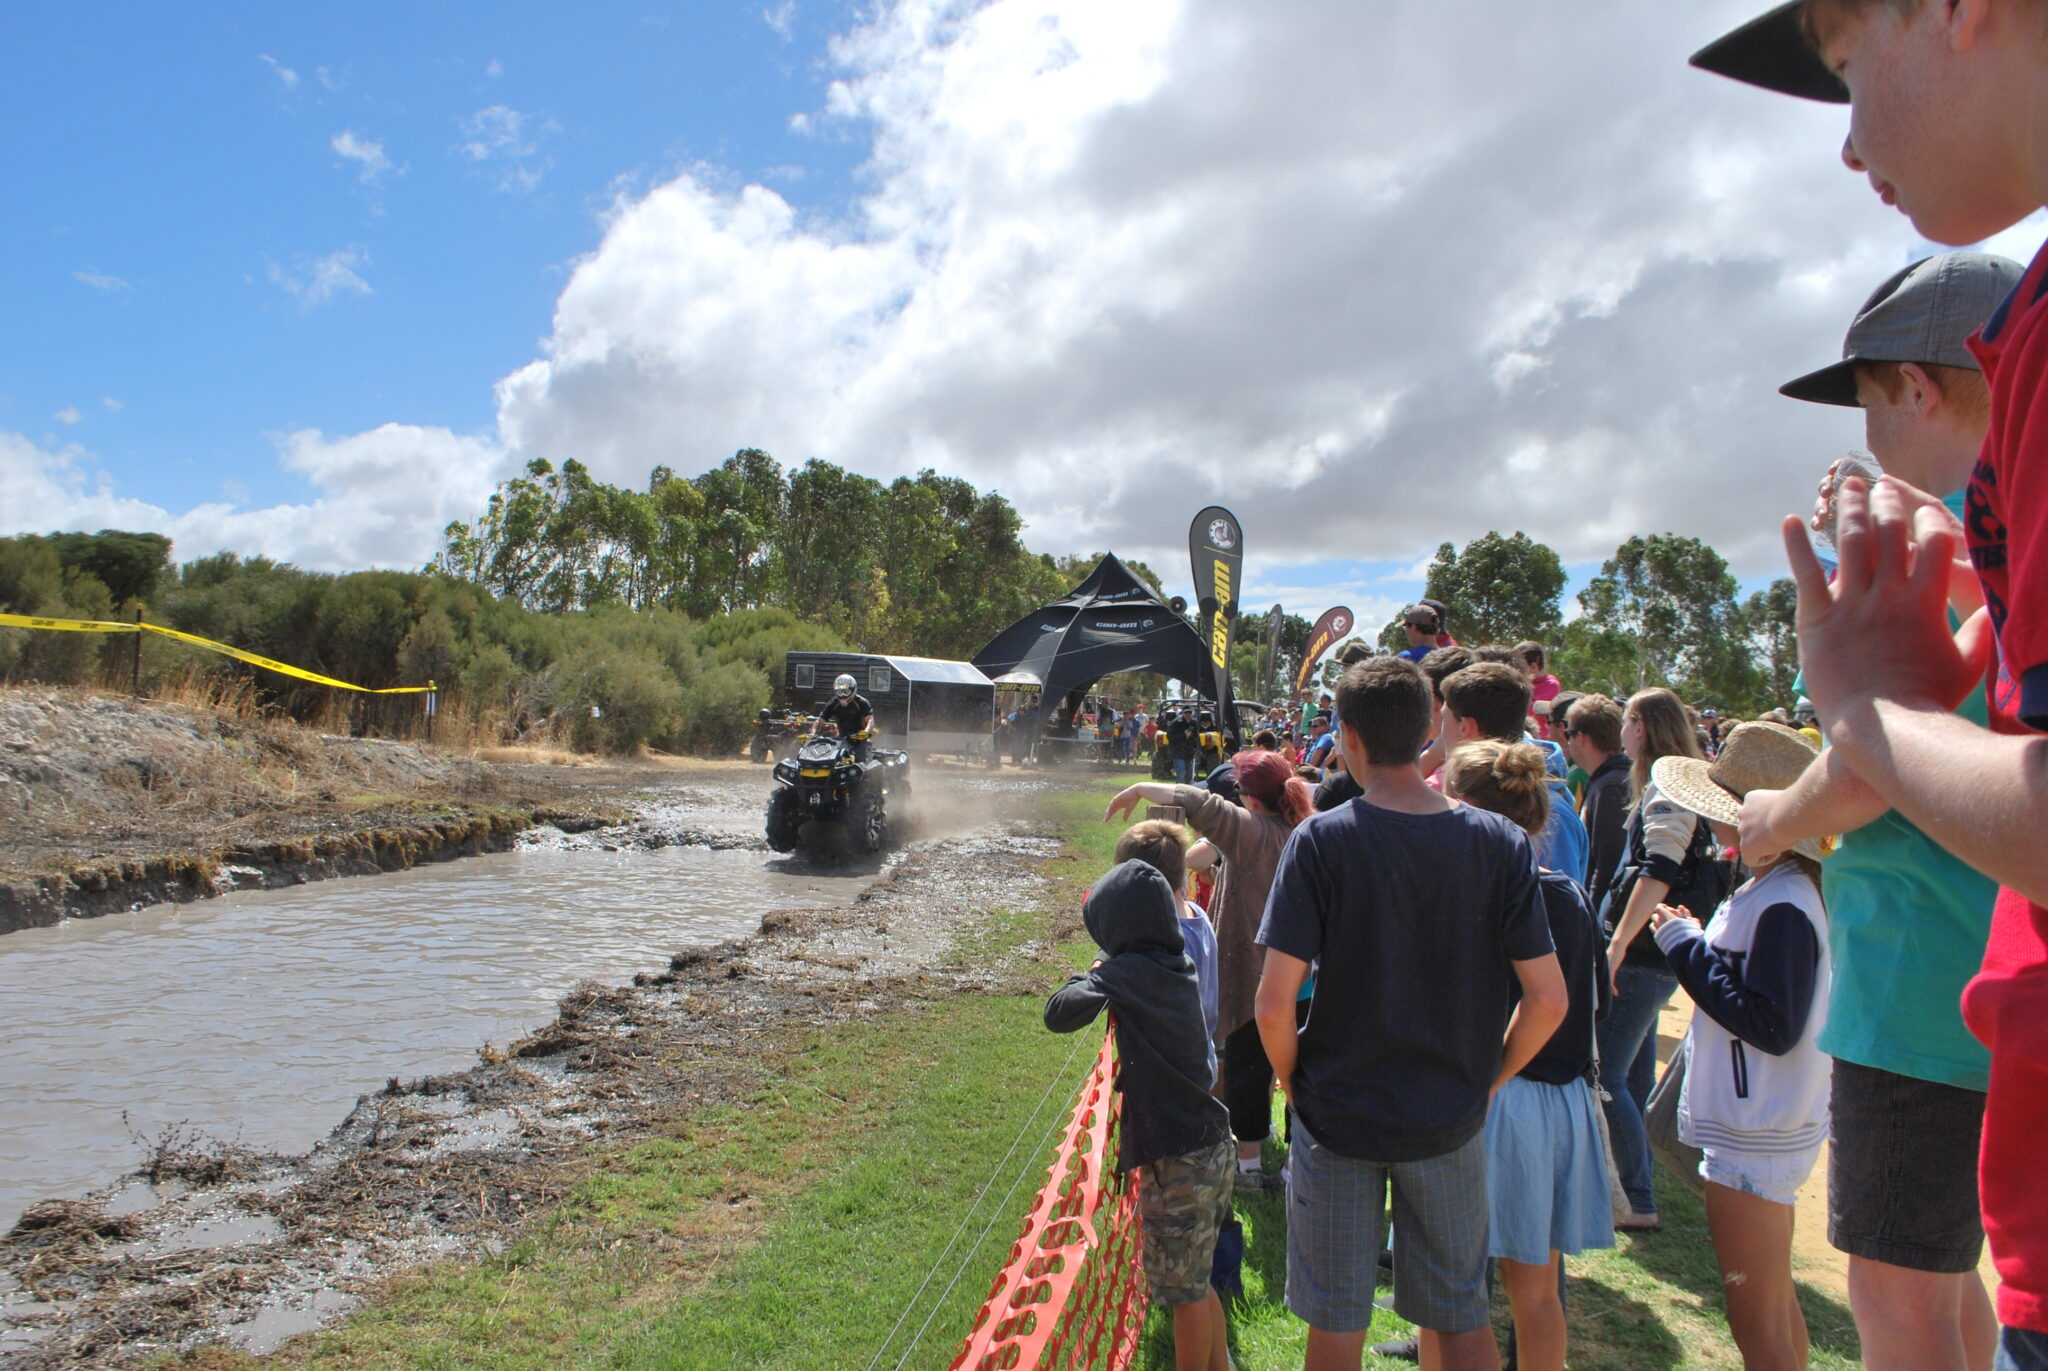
[0,795,1055,1369]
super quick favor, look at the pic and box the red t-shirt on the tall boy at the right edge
[1962,248,2048,1332]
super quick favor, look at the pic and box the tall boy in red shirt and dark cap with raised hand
[1694,0,2048,1371]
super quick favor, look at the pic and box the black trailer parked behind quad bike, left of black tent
[782,652,995,754]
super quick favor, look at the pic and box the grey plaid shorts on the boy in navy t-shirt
[1286,1115,1489,1332]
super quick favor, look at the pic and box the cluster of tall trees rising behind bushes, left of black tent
[434,447,1069,658]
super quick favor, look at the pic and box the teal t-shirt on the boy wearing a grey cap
[1819,492,1999,1090]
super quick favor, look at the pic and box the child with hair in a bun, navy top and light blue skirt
[1444,738,1614,1371]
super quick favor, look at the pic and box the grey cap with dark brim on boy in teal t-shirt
[1778,252,2025,408]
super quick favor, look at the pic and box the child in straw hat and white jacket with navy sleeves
[1655,723,1829,1367]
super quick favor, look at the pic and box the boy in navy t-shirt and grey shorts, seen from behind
[1257,658,1567,1367]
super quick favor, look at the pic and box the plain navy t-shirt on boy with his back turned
[1257,799,1552,1162]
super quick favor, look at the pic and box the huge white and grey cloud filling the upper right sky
[483,0,1966,570]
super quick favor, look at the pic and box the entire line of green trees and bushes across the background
[0,449,1798,752]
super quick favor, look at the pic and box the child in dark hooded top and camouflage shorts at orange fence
[1044,861,1233,1371]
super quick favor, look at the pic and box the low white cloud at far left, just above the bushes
[0,424,504,572]
